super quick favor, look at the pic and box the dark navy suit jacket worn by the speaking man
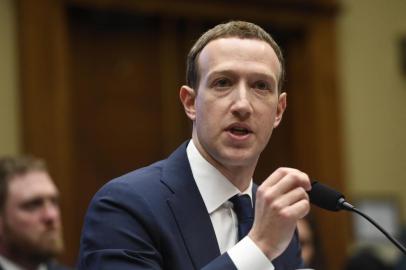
[78,143,301,270]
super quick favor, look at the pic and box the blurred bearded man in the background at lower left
[0,157,72,270]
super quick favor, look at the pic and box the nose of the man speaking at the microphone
[231,82,253,120]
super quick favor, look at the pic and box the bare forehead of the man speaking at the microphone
[198,37,281,78]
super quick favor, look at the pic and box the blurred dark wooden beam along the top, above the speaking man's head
[65,0,338,27]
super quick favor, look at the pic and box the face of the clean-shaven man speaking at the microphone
[181,38,286,173]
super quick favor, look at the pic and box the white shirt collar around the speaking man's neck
[186,140,252,214]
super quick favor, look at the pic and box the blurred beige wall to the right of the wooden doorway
[337,0,406,260]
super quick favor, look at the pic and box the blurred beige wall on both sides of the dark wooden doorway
[0,0,406,268]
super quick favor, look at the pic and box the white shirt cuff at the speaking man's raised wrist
[227,236,275,270]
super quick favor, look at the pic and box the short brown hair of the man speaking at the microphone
[186,21,285,92]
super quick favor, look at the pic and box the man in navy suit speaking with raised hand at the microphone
[78,21,310,270]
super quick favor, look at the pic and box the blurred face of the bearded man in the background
[0,171,63,260]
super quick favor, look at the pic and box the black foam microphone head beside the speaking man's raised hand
[307,181,345,211]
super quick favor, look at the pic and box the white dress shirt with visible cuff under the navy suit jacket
[186,140,274,270]
